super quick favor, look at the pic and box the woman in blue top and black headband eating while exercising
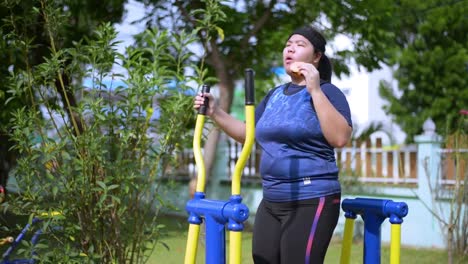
[194,27,352,264]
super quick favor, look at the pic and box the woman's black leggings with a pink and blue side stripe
[252,193,341,264]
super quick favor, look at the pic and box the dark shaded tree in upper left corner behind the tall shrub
[0,0,127,190]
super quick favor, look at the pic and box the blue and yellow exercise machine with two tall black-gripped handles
[184,69,255,264]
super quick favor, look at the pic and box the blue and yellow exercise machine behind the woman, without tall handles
[340,198,408,264]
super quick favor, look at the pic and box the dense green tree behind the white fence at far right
[380,0,468,141]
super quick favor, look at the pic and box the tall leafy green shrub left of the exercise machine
[2,1,219,263]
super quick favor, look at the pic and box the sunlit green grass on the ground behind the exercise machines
[148,214,450,264]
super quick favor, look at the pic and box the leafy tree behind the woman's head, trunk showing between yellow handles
[135,0,402,184]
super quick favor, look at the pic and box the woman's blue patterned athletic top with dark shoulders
[255,83,352,202]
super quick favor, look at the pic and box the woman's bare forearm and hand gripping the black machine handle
[193,93,245,143]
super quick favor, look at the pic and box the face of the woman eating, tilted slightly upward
[283,34,321,75]
